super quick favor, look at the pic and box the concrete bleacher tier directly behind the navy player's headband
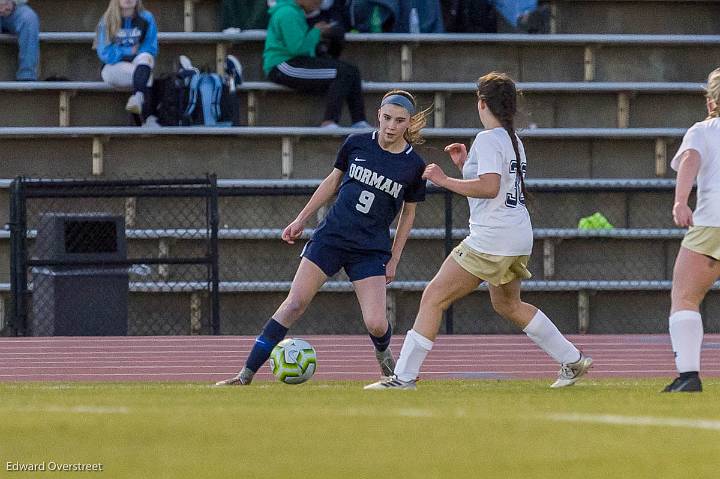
[0,82,706,128]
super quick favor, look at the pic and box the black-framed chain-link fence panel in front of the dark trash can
[10,177,217,336]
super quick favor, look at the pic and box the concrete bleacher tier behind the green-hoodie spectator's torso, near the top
[0,31,720,82]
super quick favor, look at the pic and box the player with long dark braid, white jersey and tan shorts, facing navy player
[365,72,592,389]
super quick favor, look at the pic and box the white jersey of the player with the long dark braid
[463,128,533,256]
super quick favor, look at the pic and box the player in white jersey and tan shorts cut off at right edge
[663,68,720,392]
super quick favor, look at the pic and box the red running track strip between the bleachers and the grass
[0,334,720,382]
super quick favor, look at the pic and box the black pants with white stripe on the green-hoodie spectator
[268,57,365,123]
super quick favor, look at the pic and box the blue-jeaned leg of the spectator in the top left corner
[0,0,40,81]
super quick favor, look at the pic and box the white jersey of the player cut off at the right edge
[670,118,720,227]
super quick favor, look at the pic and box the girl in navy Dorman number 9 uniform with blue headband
[217,90,428,385]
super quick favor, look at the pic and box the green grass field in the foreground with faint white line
[0,379,720,479]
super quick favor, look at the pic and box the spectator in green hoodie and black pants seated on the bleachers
[263,0,370,128]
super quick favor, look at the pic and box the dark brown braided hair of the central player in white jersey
[477,72,528,202]
